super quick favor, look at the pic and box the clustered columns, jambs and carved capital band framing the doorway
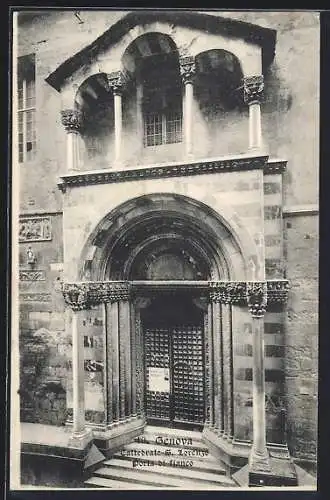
[63,280,288,462]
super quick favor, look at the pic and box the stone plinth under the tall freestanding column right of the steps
[232,457,298,487]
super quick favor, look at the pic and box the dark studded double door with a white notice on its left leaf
[145,326,204,426]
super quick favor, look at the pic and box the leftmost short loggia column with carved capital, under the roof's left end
[61,109,82,172]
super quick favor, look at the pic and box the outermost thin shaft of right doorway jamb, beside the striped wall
[221,303,233,439]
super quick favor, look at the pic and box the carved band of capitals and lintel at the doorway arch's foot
[62,280,289,308]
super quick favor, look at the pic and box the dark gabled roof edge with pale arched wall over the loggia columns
[46,11,276,107]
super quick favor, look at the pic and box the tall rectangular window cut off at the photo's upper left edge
[17,54,36,163]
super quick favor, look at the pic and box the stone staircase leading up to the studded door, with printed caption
[85,426,237,490]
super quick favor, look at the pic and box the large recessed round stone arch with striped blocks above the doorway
[78,193,260,281]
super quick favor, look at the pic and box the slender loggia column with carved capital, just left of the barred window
[107,71,126,164]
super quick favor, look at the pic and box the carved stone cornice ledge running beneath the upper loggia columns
[58,156,268,192]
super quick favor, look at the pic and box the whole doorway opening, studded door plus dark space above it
[141,293,205,430]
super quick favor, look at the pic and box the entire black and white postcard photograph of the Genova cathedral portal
[9,6,320,492]
